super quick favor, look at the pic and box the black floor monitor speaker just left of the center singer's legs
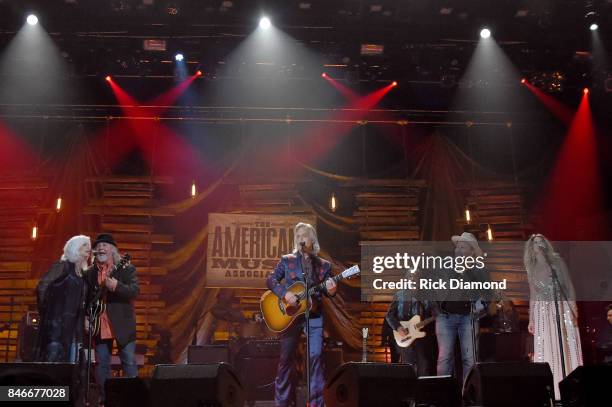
[150,363,243,407]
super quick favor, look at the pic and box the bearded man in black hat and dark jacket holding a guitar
[88,233,139,401]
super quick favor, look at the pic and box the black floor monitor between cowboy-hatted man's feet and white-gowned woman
[463,362,554,407]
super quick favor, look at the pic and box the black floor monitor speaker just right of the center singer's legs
[324,362,416,407]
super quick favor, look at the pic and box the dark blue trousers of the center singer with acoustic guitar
[274,318,325,407]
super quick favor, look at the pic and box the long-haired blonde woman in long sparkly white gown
[523,234,582,399]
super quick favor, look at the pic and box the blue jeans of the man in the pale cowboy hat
[436,313,478,381]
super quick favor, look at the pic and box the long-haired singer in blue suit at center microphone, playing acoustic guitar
[267,223,337,407]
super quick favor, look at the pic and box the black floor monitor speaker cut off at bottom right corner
[559,365,612,407]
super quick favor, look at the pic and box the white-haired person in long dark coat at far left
[36,235,91,363]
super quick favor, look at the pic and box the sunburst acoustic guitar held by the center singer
[259,265,361,332]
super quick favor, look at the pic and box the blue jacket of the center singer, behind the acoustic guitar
[266,252,331,299]
